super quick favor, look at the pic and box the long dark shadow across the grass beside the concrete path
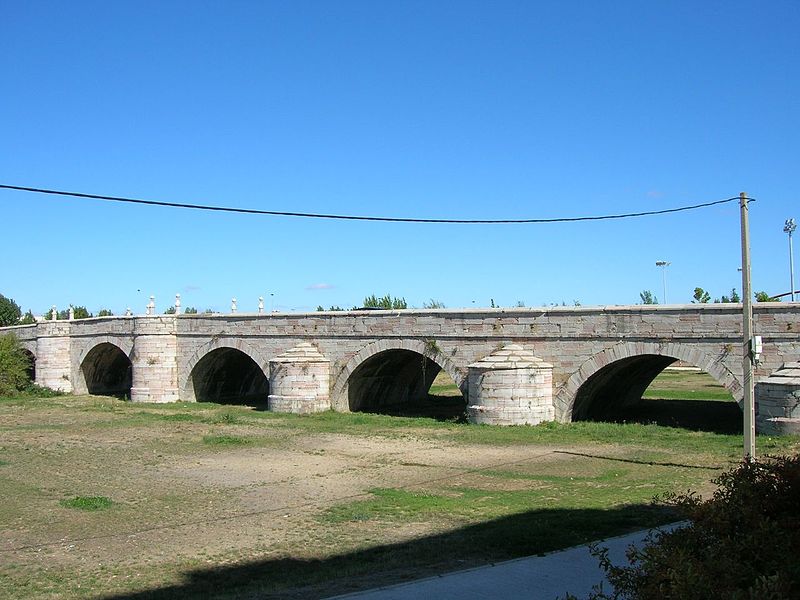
[101,505,676,600]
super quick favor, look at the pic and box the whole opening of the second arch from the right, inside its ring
[348,349,467,420]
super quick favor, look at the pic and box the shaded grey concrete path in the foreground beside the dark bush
[324,525,674,600]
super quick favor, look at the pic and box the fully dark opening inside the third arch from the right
[190,348,269,409]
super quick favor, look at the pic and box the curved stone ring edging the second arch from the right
[331,338,467,412]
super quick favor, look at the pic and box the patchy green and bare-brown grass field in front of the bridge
[0,376,800,599]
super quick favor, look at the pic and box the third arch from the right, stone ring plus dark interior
[180,337,269,403]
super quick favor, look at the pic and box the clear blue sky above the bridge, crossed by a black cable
[0,1,800,313]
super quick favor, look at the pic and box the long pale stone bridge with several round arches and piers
[0,303,800,431]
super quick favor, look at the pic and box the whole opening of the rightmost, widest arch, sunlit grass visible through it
[572,354,742,434]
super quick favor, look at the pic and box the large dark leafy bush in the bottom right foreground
[590,456,800,600]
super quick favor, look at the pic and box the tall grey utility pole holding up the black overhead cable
[739,192,756,460]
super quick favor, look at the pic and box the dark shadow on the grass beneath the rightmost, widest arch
[603,398,742,435]
